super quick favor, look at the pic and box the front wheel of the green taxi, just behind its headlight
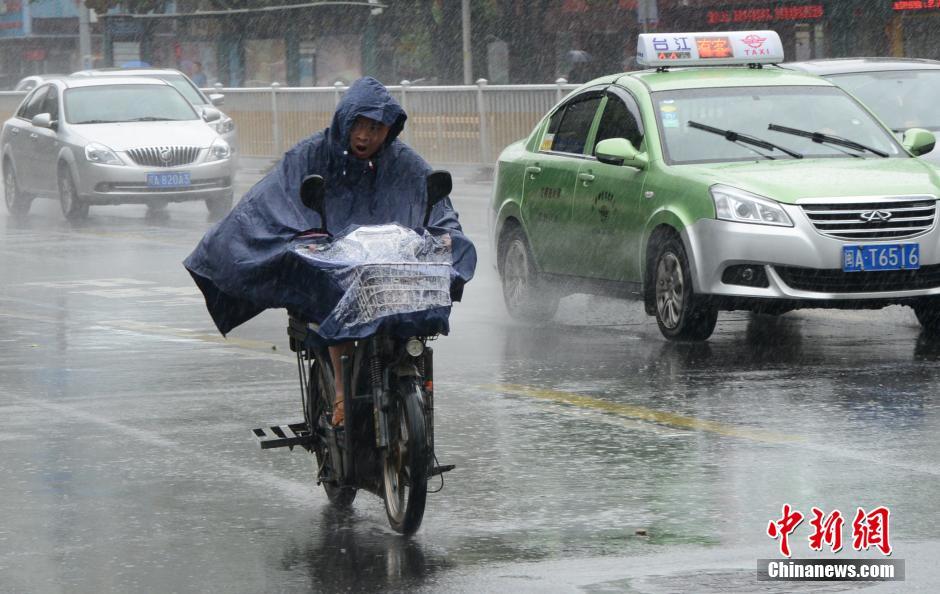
[653,237,718,340]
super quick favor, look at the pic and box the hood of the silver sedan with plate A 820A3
[72,120,219,151]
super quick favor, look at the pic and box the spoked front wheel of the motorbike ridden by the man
[382,382,430,535]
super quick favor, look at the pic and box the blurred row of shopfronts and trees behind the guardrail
[0,0,940,88]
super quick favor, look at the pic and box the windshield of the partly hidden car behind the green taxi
[830,70,940,132]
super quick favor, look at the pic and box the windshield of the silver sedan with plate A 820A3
[65,85,199,124]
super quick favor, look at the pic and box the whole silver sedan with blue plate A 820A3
[0,77,235,219]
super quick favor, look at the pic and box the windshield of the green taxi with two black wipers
[653,86,906,165]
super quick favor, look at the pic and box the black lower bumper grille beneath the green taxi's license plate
[774,264,940,293]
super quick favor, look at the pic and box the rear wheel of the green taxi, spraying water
[499,228,559,322]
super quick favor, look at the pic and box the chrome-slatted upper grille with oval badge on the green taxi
[799,196,937,241]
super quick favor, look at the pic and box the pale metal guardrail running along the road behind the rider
[0,79,578,165]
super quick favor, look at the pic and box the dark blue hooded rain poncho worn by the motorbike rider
[184,77,476,343]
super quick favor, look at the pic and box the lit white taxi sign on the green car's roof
[636,31,783,68]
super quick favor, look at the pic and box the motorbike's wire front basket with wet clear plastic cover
[294,224,453,330]
